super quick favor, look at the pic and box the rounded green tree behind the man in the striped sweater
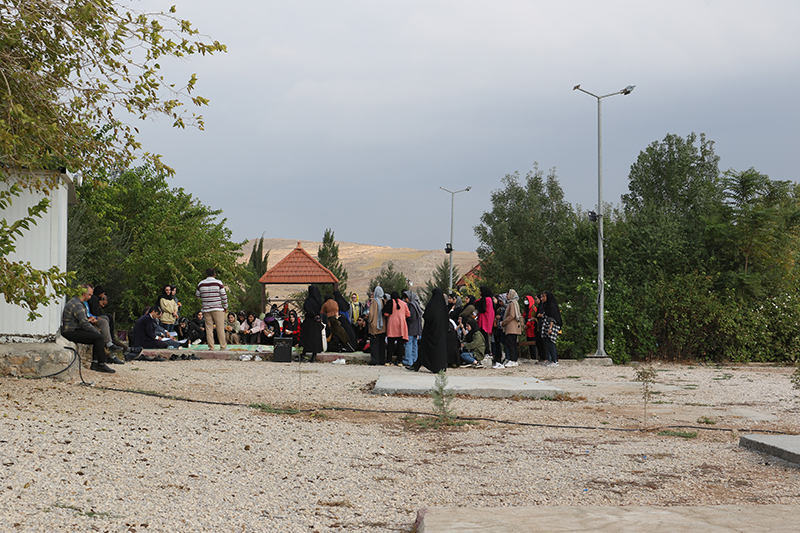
[67,165,243,322]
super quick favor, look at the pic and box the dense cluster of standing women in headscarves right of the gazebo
[299,285,562,372]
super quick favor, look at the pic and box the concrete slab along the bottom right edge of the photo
[416,505,800,533]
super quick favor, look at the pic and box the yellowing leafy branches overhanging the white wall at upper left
[0,0,225,318]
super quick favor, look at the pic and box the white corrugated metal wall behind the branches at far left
[0,170,71,342]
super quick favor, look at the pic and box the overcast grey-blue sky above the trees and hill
[133,0,800,250]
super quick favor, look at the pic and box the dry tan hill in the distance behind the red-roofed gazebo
[240,238,478,300]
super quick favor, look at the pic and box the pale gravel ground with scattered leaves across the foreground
[0,360,800,532]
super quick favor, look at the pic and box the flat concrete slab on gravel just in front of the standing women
[372,370,564,398]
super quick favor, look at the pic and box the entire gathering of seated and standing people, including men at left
[62,262,562,373]
